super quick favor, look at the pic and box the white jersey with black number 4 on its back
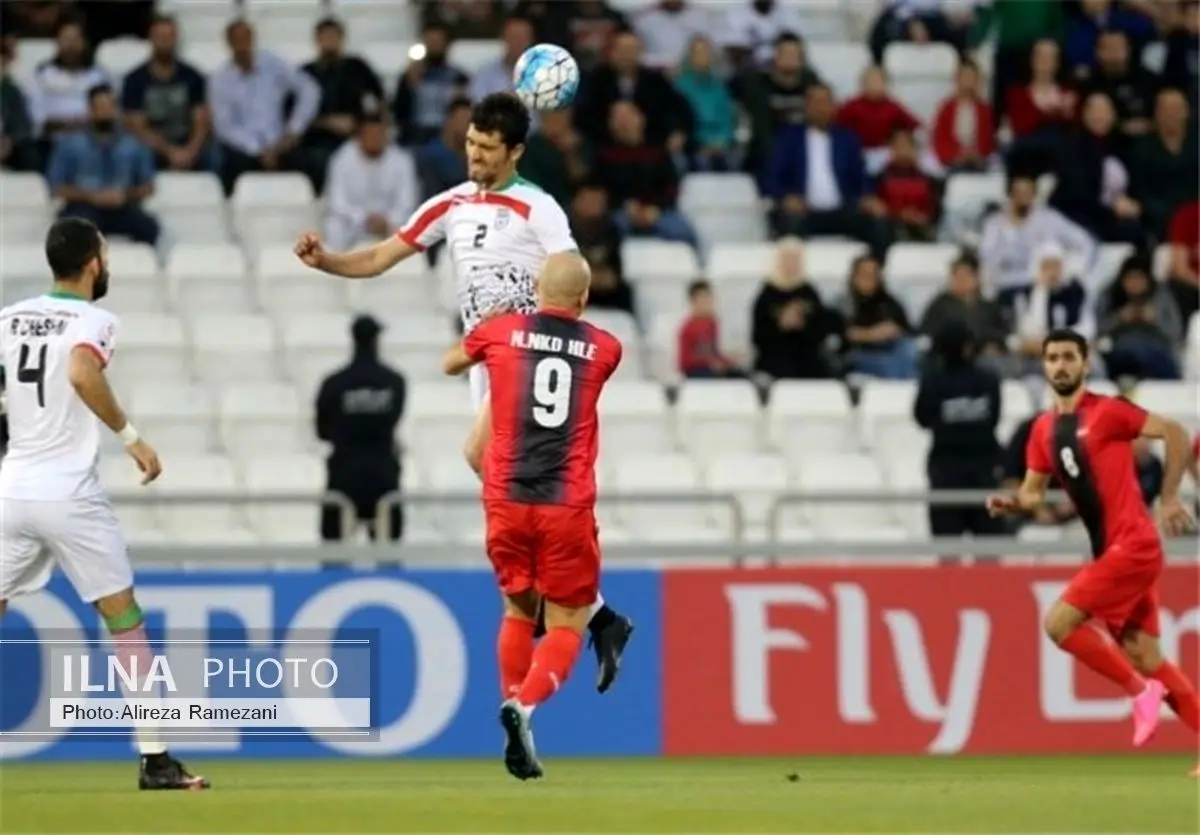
[0,293,118,501]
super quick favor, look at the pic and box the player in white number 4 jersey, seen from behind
[0,218,209,789]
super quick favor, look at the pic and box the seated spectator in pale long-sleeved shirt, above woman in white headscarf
[979,175,1096,293]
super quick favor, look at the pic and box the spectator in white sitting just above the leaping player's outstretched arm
[325,115,418,251]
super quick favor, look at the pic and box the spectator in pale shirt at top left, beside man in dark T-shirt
[29,18,109,139]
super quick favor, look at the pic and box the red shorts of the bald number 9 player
[484,501,600,608]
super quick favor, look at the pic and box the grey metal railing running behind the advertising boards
[105,491,1198,566]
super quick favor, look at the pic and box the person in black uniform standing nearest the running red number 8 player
[913,322,1004,536]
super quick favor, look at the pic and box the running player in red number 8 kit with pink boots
[988,330,1200,767]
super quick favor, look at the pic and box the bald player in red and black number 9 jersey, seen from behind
[444,250,622,780]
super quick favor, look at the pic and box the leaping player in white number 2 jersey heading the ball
[295,92,632,692]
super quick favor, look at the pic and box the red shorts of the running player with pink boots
[1062,541,1165,637]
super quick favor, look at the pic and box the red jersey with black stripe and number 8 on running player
[1025,391,1158,557]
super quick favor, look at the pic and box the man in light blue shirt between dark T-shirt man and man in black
[209,20,325,194]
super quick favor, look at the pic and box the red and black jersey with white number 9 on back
[463,308,622,507]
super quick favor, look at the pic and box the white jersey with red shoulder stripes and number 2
[396,178,578,331]
